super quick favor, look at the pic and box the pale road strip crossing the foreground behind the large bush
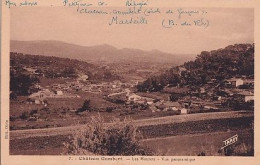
[10,111,254,140]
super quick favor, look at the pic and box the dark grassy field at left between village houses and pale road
[10,92,125,130]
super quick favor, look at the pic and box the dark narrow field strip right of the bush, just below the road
[140,117,253,138]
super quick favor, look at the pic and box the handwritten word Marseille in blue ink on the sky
[109,16,148,25]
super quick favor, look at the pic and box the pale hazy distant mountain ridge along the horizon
[10,41,191,65]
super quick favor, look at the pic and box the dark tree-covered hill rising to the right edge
[138,44,254,91]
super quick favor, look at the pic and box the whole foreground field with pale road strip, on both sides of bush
[10,112,253,156]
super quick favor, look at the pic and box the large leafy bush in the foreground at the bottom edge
[65,115,152,156]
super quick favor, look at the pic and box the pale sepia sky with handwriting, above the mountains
[10,7,254,55]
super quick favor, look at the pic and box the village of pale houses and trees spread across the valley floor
[27,67,254,117]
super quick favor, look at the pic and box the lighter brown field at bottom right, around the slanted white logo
[142,129,254,156]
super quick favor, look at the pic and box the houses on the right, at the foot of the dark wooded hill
[107,78,254,114]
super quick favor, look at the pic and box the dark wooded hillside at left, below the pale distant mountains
[10,52,118,81]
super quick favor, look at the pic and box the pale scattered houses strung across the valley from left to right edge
[28,70,254,114]
